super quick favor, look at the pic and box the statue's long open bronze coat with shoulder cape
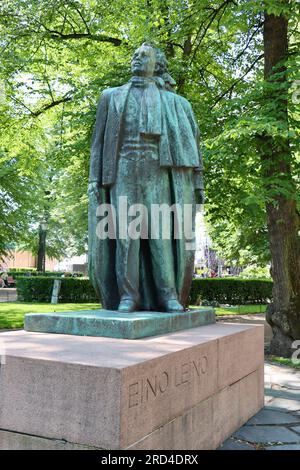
[89,83,203,310]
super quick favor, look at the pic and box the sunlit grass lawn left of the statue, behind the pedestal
[0,302,99,330]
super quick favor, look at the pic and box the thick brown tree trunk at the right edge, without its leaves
[260,13,300,357]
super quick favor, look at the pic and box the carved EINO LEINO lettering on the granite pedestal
[128,355,208,408]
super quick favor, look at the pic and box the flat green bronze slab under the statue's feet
[25,308,216,339]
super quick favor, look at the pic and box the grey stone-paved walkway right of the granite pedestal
[219,363,300,450]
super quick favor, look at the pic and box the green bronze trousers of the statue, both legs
[111,156,177,303]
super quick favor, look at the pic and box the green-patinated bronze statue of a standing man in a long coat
[89,44,203,312]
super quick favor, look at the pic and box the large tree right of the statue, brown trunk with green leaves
[198,0,300,357]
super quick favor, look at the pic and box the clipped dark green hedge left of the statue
[16,276,99,303]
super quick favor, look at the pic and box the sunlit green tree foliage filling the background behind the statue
[0,0,300,265]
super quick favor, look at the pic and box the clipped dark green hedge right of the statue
[189,278,273,305]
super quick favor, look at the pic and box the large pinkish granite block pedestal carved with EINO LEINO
[0,323,264,450]
